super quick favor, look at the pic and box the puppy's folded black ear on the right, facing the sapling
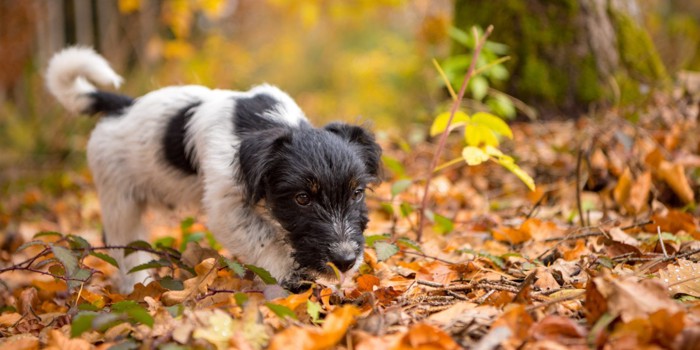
[325,122,382,181]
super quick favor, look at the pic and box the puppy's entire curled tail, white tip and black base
[46,47,134,114]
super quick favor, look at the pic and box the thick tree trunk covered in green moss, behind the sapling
[455,0,668,111]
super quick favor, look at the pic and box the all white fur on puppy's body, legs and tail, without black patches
[47,48,306,292]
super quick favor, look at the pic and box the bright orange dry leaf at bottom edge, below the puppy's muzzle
[269,305,360,350]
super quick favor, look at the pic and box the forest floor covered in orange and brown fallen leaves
[0,78,700,349]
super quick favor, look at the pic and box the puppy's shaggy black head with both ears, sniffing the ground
[239,123,381,276]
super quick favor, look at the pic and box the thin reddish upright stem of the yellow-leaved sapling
[416,26,493,243]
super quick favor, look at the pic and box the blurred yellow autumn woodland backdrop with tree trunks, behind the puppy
[0,0,700,200]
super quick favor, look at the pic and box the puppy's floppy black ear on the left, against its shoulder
[238,128,292,205]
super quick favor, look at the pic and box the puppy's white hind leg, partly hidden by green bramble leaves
[100,191,153,293]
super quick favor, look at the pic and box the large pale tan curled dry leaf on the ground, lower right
[594,277,681,322]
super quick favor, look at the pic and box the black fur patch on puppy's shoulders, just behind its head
[233,94,280,136]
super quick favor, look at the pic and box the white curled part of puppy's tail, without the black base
[46,46,123,114]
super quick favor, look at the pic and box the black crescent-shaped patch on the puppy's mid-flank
[163,101,201,175]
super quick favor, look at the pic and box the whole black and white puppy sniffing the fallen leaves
[46,47,381,291]
